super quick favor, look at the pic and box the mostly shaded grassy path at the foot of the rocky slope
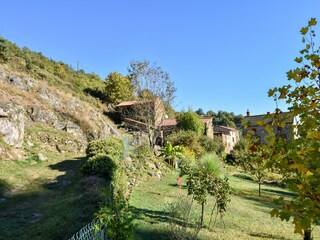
[0,154,98,240]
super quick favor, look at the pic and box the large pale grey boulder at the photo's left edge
[0,100,24,147]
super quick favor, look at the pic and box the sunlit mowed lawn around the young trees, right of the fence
[130,175,320,240]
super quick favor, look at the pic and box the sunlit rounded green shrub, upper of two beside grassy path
[86,137,125,160]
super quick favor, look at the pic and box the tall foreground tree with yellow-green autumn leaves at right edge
[253,18,320,239]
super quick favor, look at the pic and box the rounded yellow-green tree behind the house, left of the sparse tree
[105,72,133,104]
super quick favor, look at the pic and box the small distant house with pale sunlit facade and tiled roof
[213,126,240,153]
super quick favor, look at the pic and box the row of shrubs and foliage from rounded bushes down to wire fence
[82,137,134,240]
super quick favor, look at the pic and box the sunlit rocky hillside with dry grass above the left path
[0,65,118,158]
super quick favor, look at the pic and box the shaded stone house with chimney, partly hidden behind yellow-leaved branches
[242,110,297,143]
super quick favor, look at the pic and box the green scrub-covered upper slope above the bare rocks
[0,37,104,103]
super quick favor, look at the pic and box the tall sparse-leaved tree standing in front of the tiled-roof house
[128,60,176,148]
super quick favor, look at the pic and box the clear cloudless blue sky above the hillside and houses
[0,0,320,115]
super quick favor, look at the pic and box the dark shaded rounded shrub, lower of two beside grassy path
[82,154,119,181]
